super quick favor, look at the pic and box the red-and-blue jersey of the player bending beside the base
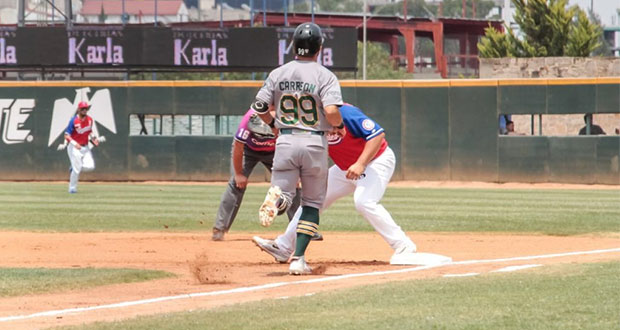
[327,103,388,171]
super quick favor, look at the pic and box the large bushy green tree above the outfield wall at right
[478,0,602,57]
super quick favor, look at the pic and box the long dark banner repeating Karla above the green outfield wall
[0,25,357,71]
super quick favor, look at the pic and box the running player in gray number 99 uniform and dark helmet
[252,23,344,275]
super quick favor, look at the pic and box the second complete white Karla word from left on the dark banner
[174,39,228,66]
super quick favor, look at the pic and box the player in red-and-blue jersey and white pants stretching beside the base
[253,104,418,265]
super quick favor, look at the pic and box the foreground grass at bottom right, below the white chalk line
[63,262,620,330]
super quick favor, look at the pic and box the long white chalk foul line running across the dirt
[0,248,620,322]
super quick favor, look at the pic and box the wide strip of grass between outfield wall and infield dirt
[0,182,620,235]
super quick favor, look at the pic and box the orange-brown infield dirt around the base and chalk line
[0,232,620,329]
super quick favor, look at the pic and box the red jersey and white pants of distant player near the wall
[65,115,95,193]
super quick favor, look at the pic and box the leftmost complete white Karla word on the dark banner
[69,37,124,64]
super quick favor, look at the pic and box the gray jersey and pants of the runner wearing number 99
[256,60,342,209]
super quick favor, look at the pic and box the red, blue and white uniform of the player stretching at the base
[275,104,416,260]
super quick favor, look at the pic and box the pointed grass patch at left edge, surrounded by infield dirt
[0,268,175,297]
